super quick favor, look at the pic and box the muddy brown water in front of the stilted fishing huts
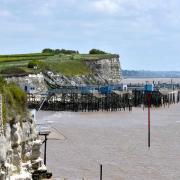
[36,104,180,180]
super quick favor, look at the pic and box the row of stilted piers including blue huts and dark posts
[27,85,180,112]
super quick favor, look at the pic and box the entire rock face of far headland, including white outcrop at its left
[7,55,122,88]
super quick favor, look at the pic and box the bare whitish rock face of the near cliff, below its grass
[0,112,46,180]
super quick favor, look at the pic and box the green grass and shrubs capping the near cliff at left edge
[0,77,27,124]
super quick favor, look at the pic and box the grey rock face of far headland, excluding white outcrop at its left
[45,55,122,86]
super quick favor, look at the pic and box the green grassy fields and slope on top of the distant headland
[0,53,118,76]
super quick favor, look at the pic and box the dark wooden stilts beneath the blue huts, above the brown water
[28,90,180,112]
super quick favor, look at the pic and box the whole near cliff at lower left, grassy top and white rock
[0,78,50,180]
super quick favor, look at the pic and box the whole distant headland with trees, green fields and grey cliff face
[0,49,122,85]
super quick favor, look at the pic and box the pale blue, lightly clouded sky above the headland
[0,0,180,71]
